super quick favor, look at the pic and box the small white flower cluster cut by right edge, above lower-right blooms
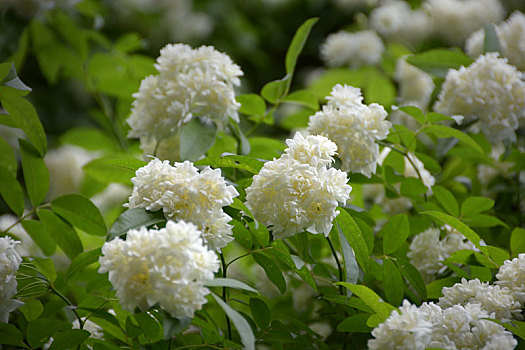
[496,254,525,303]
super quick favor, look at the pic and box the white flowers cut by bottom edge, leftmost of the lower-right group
[368,300,433,350]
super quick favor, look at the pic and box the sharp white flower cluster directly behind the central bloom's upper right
[307,84,391,177]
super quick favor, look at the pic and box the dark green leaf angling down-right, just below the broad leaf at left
[37,210,84,260]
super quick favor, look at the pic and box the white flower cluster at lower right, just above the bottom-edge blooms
[438,278,523,320]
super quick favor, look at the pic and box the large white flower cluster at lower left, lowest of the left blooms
[99,221,219,318]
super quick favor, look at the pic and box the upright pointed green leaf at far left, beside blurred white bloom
[18,139,49,207]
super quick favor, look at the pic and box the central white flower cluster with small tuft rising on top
[246,133,352,238]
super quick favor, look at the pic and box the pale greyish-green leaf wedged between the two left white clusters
[107,208,166,241]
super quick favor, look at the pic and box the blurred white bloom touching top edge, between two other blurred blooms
[369,0,431,46]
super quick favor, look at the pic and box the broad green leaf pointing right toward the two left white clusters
[51,194,107,236]
